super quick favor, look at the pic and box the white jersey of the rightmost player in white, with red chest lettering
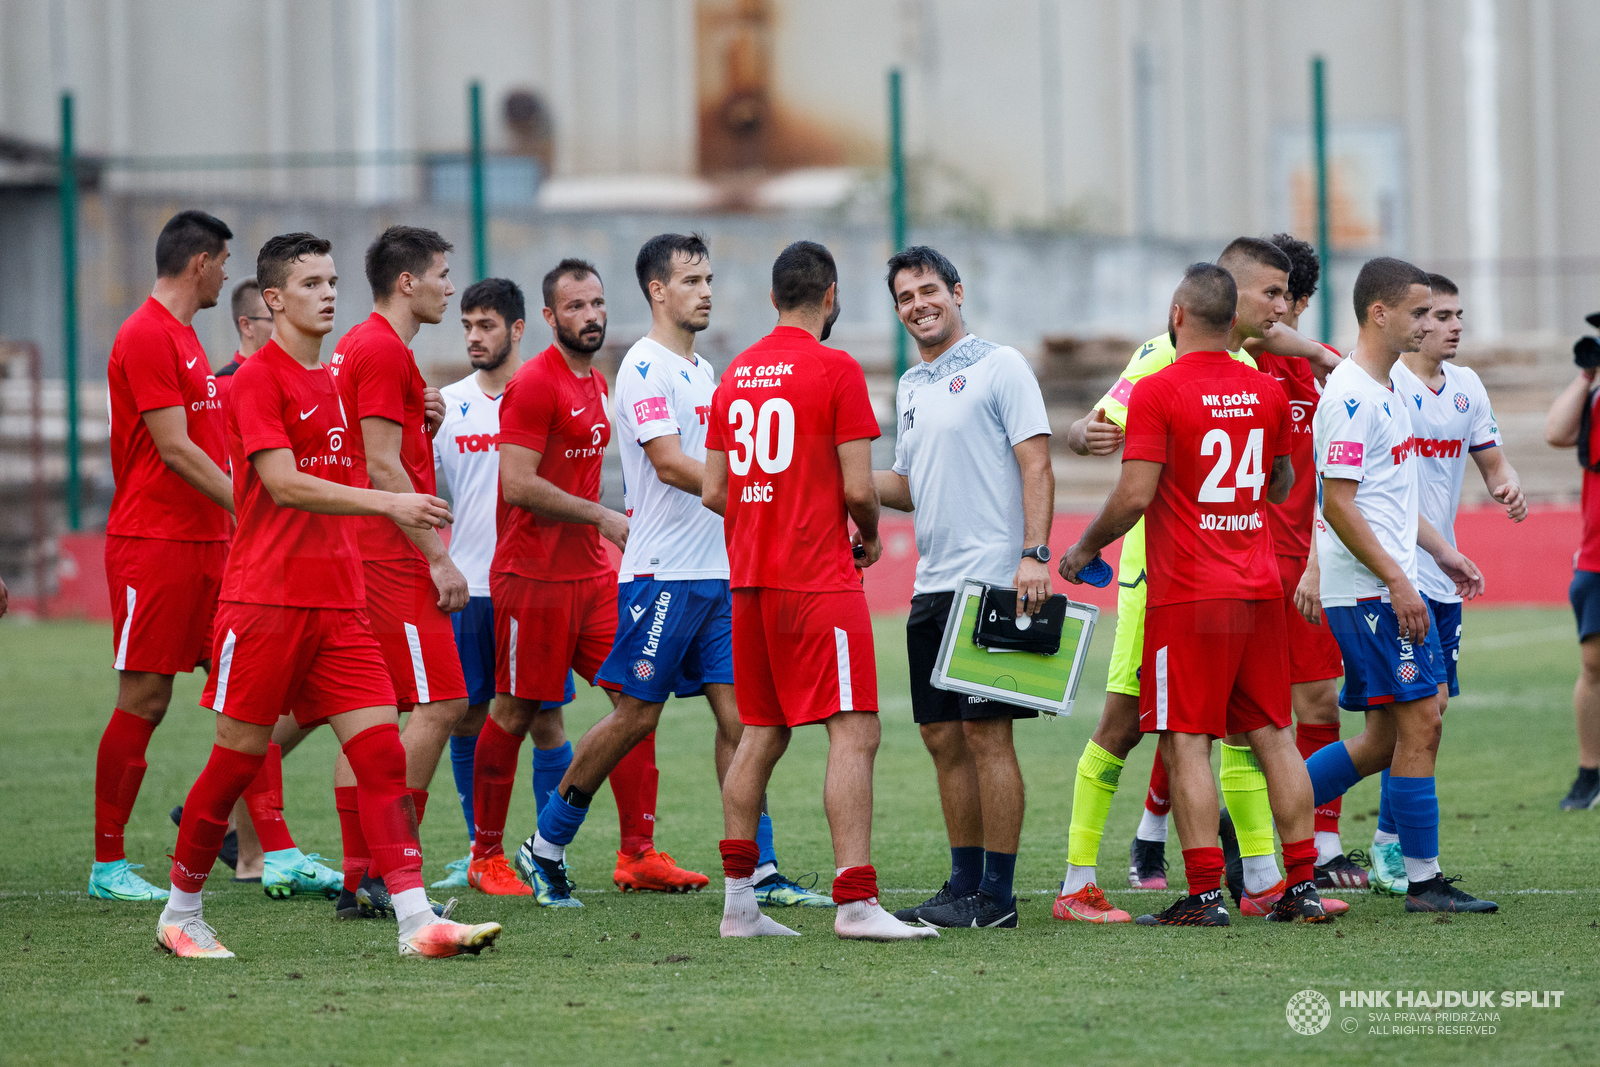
[1392,363,1501,603]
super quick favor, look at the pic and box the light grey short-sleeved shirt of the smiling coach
[894,334,1050,593]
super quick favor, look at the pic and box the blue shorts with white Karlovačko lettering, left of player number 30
[595,577,733,704]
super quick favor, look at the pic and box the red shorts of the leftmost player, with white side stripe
[106,536,227,675]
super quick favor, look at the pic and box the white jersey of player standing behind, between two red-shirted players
[434,371,499,597]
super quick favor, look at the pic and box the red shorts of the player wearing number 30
[733,589,878,726]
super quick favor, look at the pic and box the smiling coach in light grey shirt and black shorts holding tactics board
[874,245,1056,928]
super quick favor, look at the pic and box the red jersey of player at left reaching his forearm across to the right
[221,341,364,608]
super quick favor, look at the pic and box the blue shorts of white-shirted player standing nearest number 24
[1322,600,1445,712]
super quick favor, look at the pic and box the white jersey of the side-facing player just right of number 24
[1312,360,1421,608]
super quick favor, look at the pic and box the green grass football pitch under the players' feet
[0,609,1600,1067]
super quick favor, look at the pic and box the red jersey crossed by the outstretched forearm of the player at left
[331,312,438,560]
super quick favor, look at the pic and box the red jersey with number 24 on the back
[1122,352,1294,608]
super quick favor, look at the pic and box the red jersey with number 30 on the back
[706,326,878,592]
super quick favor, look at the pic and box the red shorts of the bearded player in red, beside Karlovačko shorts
[490,573,616,702]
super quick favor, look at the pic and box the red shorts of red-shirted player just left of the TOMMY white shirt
[362,558,467,712]
